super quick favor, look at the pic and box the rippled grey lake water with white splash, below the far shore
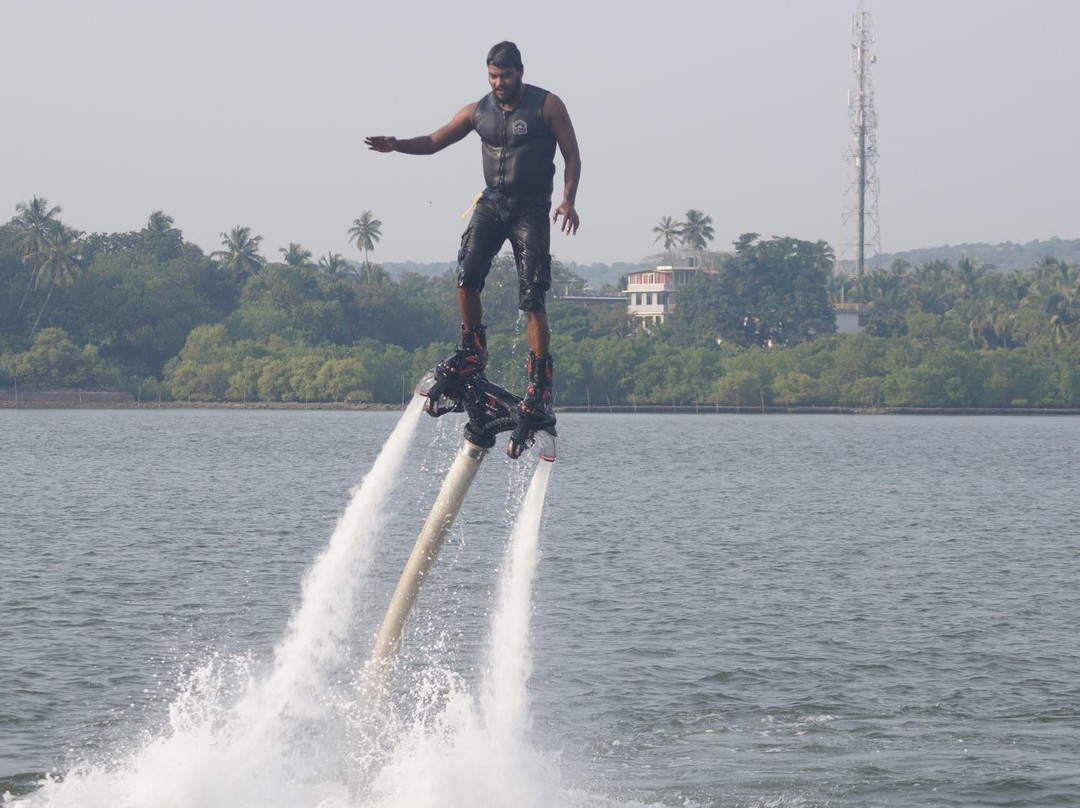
[0,409,1080,808]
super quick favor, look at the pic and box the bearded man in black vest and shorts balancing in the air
[364,42,581,425]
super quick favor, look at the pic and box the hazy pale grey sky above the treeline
[0,0,1080,264]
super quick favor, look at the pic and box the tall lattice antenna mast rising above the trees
[837,5,881,274]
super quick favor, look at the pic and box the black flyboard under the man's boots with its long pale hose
[349,371,556,802]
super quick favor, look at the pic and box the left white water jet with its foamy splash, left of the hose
[13,396,423,808]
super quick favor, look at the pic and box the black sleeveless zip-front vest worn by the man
[473,84,555,201]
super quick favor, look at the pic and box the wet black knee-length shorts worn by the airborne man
[458,194,551,312]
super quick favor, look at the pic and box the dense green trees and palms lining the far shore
[0,199,1080,408]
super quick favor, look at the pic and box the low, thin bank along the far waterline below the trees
[0,388,1080,416]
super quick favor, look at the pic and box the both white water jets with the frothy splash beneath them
[4,406,608,808]
